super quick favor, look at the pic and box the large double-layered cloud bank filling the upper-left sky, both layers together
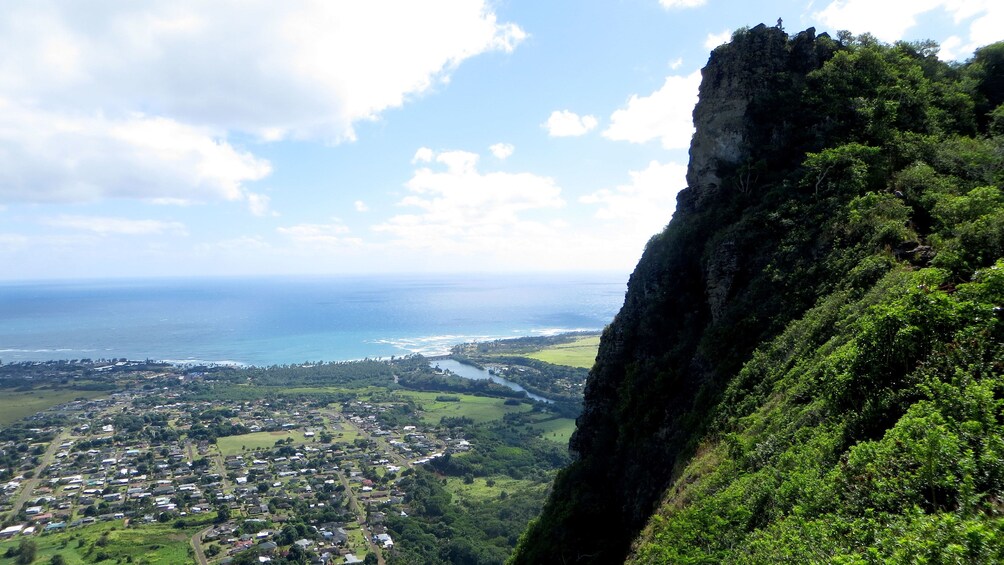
[0,0,526,205]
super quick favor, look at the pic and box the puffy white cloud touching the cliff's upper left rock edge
[603,71,701,150]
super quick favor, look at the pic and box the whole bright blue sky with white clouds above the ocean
[0,0,1004,280]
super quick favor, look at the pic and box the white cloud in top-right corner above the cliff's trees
[812,0,1004,51]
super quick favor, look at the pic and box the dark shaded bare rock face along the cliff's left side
[525,25,832,563]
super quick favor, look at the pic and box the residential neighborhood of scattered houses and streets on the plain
[0,361,554,564]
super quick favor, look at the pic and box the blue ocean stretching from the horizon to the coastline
[0,274,626,365]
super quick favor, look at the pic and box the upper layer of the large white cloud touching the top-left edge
[0,4,526,140]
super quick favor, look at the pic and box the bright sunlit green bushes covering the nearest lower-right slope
[636,261,1004,563]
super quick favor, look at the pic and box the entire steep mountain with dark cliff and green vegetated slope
[513,25,1004,563]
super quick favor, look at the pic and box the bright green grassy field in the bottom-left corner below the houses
[0,520,205,565]
